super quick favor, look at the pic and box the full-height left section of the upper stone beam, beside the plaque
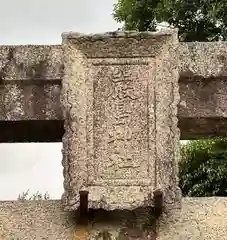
[0,45,64,142]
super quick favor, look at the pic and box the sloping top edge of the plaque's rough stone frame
[62,30,172,58]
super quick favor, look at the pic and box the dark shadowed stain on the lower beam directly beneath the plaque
[69,207,157,240]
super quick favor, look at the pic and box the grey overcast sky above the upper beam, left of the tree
[0,0,119,44]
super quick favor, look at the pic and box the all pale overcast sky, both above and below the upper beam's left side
[0,0,119,200]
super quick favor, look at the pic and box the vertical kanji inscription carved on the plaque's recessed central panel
[94,64,148,179]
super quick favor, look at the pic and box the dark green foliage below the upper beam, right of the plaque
[179,138,227,197]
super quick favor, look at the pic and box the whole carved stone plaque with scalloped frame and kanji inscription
[61,32,179,210]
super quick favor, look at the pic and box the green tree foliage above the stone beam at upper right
[113,0,227,42]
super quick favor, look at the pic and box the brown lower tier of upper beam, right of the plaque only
[178,76,227,139]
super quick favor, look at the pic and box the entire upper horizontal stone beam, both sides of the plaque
[0,42,227,142]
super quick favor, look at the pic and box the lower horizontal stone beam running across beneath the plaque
[0,198,227,240]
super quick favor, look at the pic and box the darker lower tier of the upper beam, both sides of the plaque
[0,77,227,142]
